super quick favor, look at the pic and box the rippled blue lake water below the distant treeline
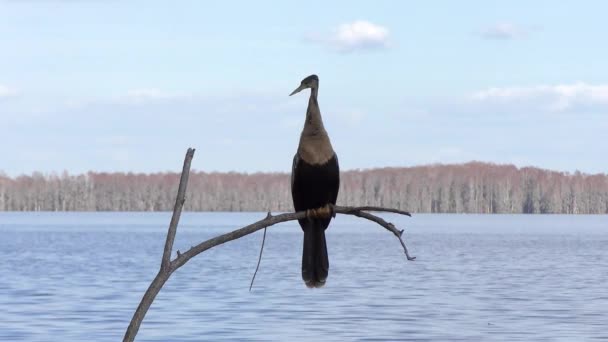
[0,213,608,341]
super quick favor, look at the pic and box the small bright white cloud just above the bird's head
[310,20,389,52]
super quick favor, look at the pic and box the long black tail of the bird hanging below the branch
[302,220,329,287]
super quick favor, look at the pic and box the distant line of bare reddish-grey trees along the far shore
[0,162,608,214]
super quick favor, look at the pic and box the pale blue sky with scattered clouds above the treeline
[0,0,608,176]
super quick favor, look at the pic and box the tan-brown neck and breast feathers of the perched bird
[298,88,334,165]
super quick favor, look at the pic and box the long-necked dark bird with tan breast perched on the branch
[289,75,340,288]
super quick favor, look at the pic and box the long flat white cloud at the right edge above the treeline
[470,82,608,111]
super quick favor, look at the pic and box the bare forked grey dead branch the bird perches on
[123,148,415,342]
